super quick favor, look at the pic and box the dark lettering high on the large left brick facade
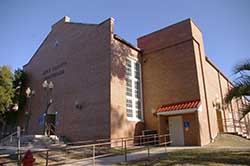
[42,62,67,80]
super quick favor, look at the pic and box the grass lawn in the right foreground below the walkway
[117,149,250,166]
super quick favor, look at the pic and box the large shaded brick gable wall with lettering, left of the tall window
[24,16,112,141]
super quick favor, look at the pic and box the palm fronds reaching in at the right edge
[225,59,250,118]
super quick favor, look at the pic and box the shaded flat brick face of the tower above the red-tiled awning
[138,20,200,139]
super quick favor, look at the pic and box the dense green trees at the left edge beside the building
[0,66,27,135]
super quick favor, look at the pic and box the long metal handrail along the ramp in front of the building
[0,134,171,165]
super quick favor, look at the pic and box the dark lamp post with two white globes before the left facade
[42,80,54,135]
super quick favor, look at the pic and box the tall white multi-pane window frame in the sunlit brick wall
[125,56,144,121]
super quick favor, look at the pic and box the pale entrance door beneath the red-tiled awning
[168,116,184,145]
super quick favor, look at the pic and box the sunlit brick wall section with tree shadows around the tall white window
[110,34,144,138]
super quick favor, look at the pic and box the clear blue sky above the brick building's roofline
[0,0,250,78]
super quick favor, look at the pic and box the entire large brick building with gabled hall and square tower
[24,17,250,145]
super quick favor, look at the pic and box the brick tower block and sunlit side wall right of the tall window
[138,19,247,145]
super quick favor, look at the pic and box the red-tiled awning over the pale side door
[156,100,200,115]
